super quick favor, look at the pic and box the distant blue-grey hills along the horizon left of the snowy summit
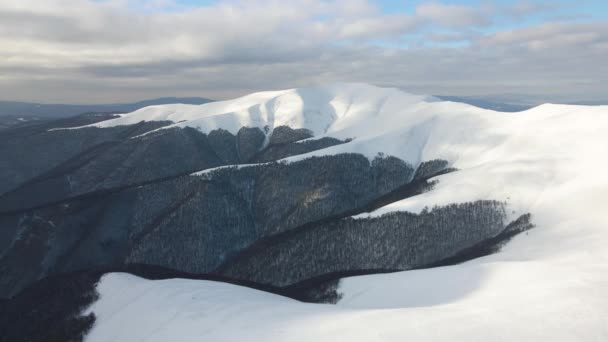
[0,97,213,120]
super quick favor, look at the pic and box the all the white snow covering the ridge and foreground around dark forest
[87,84,608,341]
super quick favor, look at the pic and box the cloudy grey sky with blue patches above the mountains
[0,0,608,103]
